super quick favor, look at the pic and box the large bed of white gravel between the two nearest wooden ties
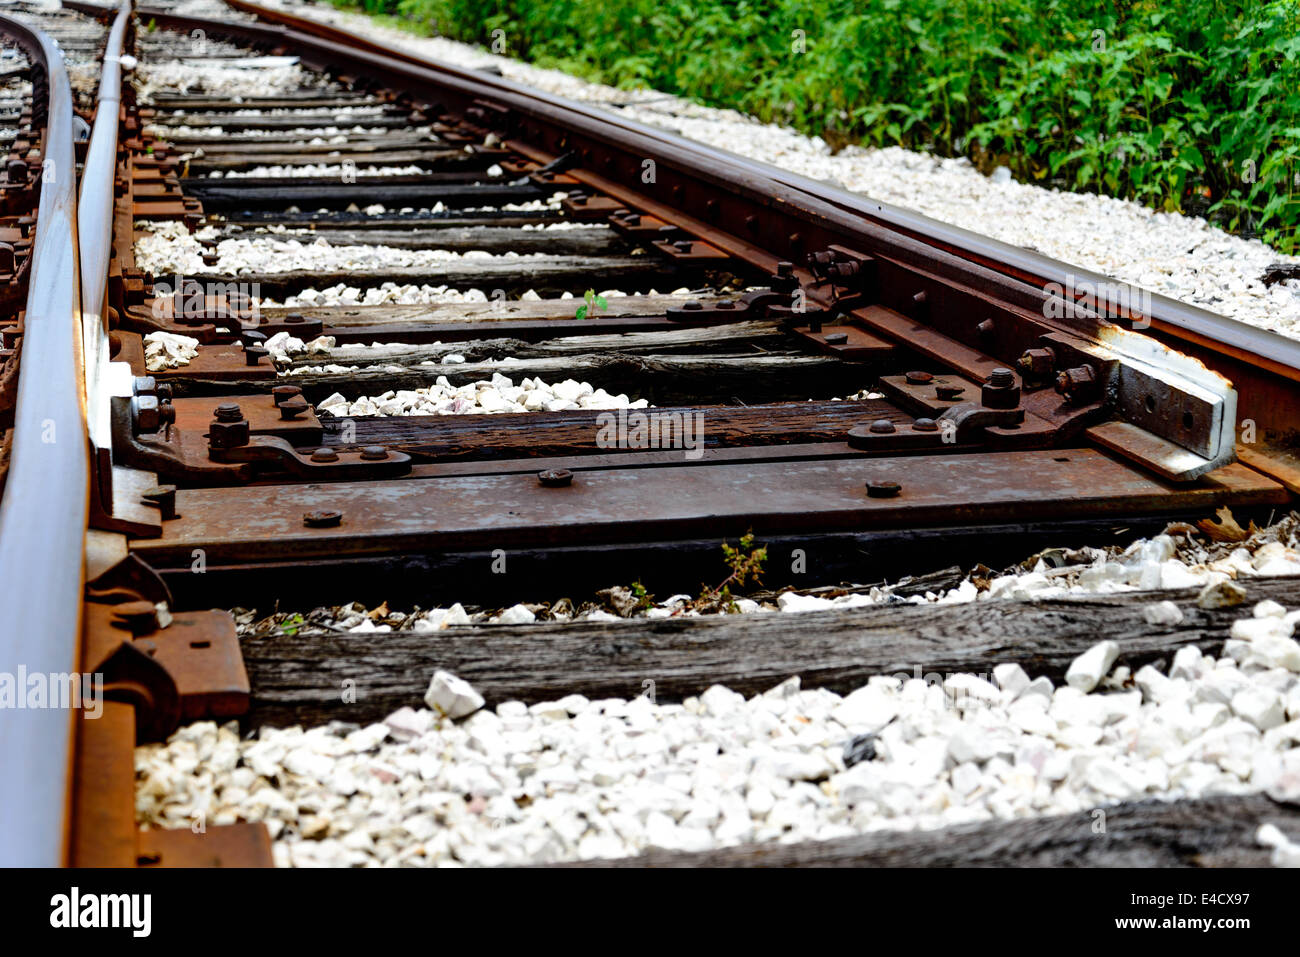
[137,602,1300,866]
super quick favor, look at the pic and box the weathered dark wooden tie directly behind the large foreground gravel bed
[243,579,1300,724]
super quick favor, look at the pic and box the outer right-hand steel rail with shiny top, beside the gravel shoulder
[218,0,1300,381]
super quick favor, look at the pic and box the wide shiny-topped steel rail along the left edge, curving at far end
[0,14,90,866]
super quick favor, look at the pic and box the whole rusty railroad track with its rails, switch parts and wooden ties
[0,0,1300,866]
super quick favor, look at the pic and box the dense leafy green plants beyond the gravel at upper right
[337,0,1300,252]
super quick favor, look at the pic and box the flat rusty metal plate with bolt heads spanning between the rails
[126,450,1287,567]
